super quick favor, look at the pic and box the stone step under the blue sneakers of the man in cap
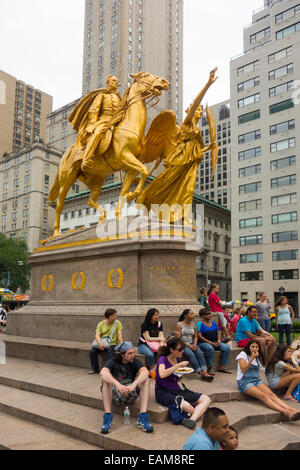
[0,385,300,450]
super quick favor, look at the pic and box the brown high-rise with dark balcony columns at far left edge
[0,70,52,158]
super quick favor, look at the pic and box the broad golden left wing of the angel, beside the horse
[141,110,179,163]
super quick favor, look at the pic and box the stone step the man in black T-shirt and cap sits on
[0,357,242,423]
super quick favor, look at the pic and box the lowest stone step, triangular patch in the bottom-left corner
[0,413,102,450]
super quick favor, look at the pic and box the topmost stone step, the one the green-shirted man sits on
[0,334,241,369]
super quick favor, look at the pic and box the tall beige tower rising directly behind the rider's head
[82,0,183,121]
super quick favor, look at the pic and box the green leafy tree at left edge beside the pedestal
[0,233,30,292]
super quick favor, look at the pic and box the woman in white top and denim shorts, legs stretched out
[236,340,300,421]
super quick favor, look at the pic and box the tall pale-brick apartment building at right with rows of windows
[231,0,300,313]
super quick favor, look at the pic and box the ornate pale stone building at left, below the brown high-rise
[0,143,62,252]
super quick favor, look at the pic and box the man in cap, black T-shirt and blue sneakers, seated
[100,341,153,434]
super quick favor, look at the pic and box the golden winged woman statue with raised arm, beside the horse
[137,69,218,223]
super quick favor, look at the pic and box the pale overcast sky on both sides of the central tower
[0,0,263,109]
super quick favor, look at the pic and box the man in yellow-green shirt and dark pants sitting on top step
[89,308,123,374]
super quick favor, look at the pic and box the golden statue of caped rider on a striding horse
[48,72,169,237]
